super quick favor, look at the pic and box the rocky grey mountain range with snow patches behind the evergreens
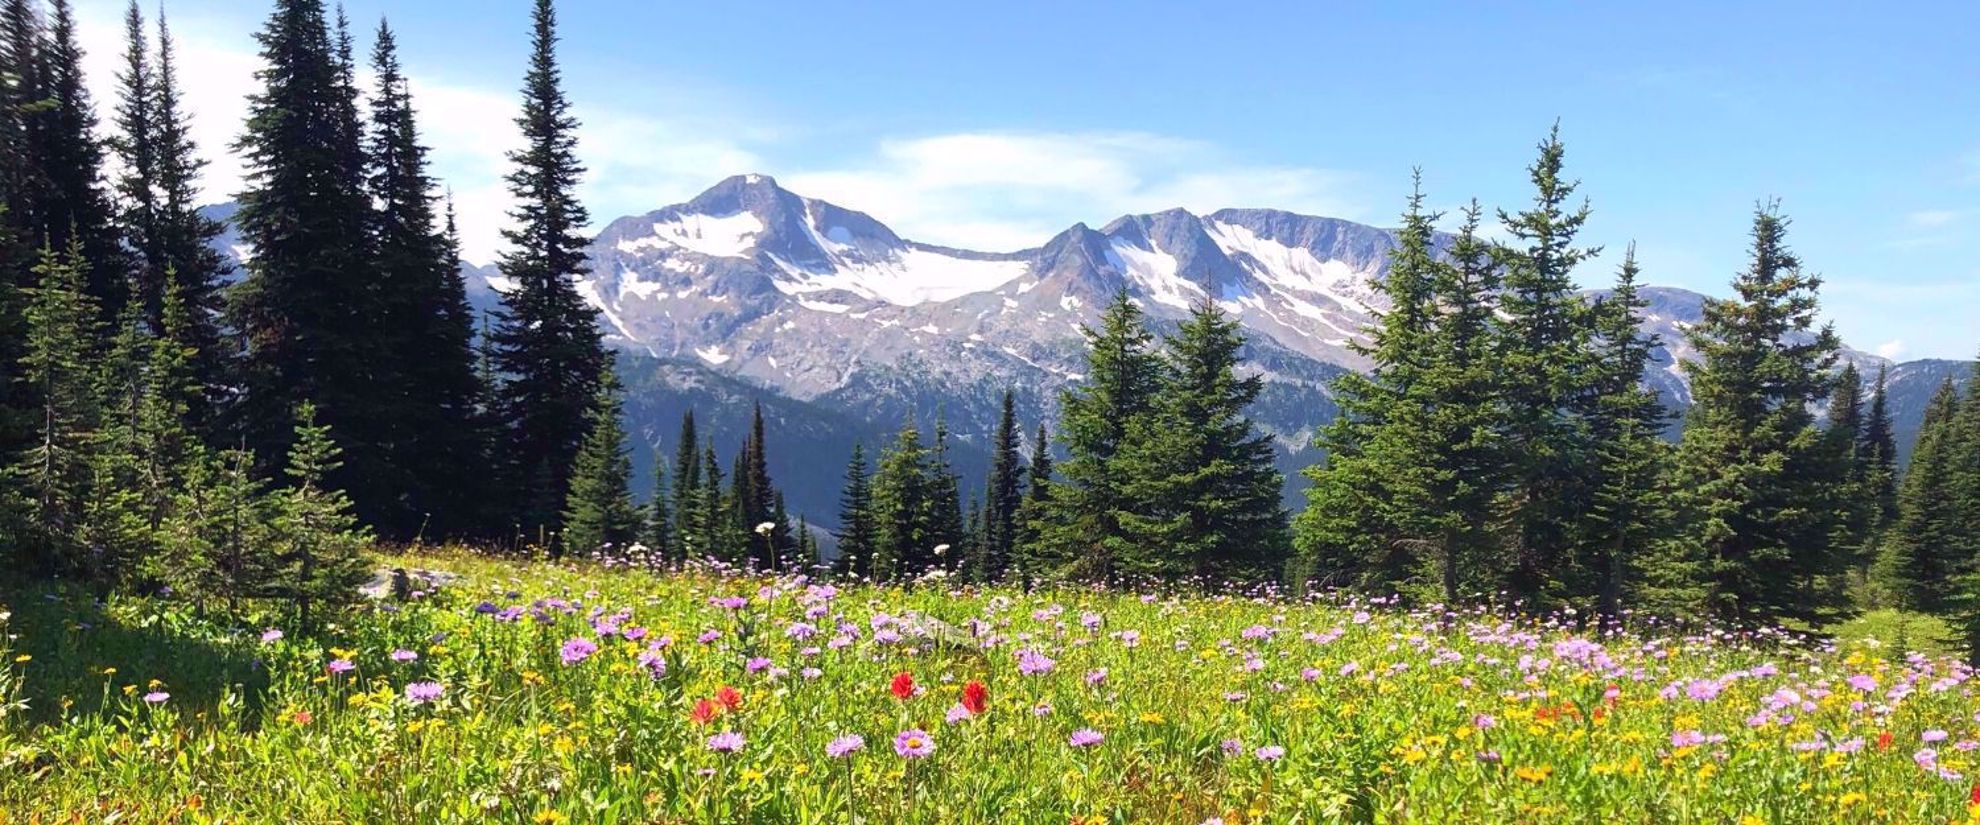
[200,174,1958,524]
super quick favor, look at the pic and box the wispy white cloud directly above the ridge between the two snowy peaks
[782,133,1360,249]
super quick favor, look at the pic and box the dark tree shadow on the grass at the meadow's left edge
[0,584,267,722]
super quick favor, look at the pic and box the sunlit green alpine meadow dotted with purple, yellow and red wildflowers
[0,556,1980,825]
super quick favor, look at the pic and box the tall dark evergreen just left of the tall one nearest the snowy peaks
[366,22,491,536]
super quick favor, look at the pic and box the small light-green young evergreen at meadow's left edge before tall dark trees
[271,402,370,631]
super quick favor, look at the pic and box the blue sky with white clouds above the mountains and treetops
[79,0,1980,358]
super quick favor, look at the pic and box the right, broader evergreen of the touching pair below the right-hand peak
[1119,299,1289,584]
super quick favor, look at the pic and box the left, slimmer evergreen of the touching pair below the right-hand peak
[1030,289,1162,580]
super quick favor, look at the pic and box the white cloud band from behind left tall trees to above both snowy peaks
[77,7,1362,263]
